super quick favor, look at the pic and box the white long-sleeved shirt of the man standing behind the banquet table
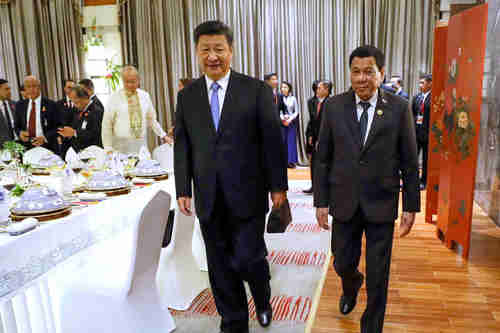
[102,89,167,153]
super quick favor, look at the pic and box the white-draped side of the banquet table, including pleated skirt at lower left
[0,177,179,332]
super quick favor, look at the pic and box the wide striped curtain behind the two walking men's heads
[121,0,436,163]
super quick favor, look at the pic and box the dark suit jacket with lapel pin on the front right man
[314,90,420,222]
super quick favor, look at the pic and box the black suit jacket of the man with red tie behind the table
[16,96,61,153]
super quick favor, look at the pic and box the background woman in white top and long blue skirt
[280,81,299,169]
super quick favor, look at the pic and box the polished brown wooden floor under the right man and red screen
[289,169,500,333]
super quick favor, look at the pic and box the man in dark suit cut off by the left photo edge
[0,79,18,149]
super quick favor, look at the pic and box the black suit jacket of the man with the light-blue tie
[174,71,288,221]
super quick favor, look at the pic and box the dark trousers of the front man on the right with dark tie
[332,208,394,333]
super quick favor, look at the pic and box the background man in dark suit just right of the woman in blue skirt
[303,81,333,194]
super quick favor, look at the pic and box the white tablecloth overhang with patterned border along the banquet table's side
[0,177,175,304]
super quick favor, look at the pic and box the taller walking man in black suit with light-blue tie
[174,21,288,333]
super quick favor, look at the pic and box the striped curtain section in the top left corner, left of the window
[0,0,83,99]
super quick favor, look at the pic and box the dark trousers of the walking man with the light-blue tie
[200,186,271,333]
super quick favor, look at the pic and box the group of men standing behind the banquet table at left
[0,66,177,158]
